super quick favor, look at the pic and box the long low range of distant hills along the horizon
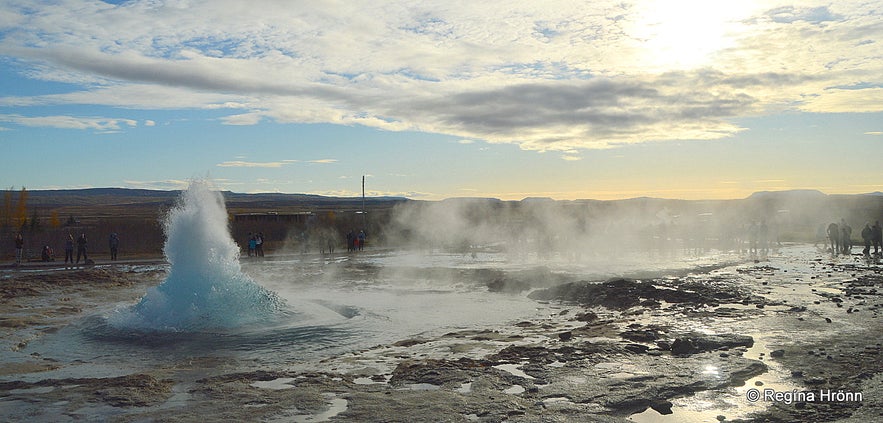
[13,188,883,227]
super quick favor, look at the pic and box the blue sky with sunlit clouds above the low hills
[0,0,883,200]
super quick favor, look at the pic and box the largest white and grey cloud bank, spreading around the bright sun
[0,0,883,152]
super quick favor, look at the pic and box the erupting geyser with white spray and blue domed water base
[109,181,282,331]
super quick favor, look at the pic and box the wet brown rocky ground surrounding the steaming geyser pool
[0,247,883,422]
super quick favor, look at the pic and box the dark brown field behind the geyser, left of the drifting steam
[0,192,401,262]
